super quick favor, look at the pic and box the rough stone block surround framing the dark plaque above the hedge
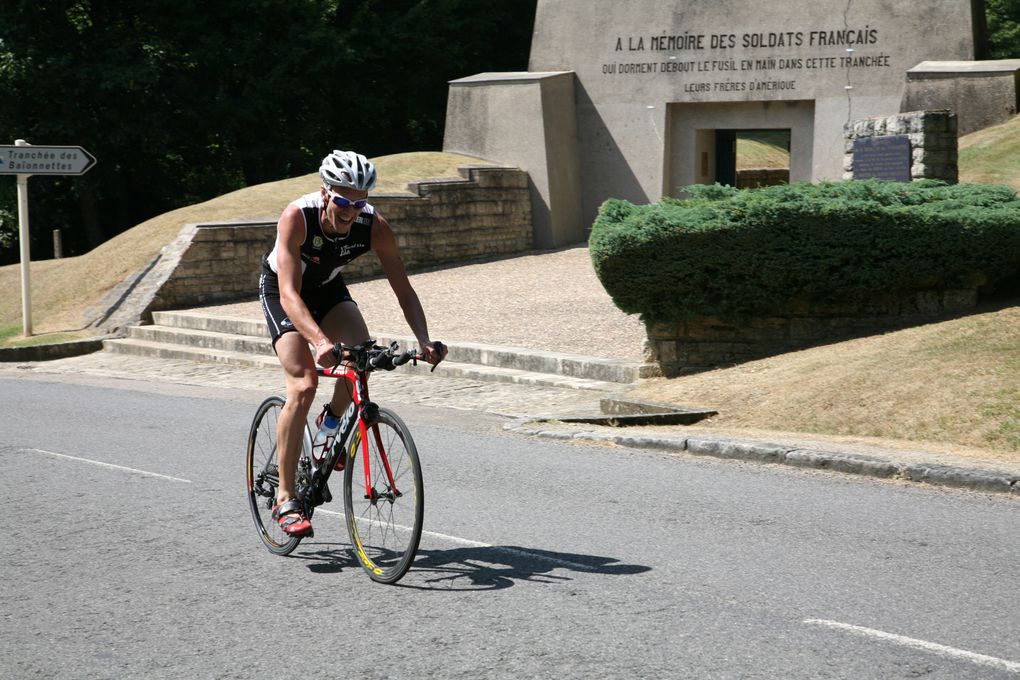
[843,110,960,184]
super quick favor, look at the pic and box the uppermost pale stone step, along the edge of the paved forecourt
[147,312,643,384]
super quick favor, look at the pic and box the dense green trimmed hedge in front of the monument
[590,179,1020,322]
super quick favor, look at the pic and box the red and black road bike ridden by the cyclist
[247,341,436,583]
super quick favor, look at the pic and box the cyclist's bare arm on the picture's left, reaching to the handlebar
[276,204,336,368]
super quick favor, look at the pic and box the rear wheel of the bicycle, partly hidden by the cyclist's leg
[247,397,311,556]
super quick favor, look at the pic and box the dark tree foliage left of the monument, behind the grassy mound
[0,0,536,263]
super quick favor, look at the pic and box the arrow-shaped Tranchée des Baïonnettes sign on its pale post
[0,140,96,336]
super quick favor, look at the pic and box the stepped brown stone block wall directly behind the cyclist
[148,165,532,314]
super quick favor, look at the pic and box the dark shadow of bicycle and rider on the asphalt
[296,543,652,591]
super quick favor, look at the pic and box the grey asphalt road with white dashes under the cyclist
[0,378,1020,679]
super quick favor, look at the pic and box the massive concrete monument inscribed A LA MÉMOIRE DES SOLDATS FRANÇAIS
[444,0,1020,248]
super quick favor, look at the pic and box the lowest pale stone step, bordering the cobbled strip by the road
[103,336,620,393]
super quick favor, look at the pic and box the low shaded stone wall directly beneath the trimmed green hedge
[646,287,977,376]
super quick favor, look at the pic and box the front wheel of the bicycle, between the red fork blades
[344,409,425,583]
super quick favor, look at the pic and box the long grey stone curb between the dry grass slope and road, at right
[503,418,1020,499]
